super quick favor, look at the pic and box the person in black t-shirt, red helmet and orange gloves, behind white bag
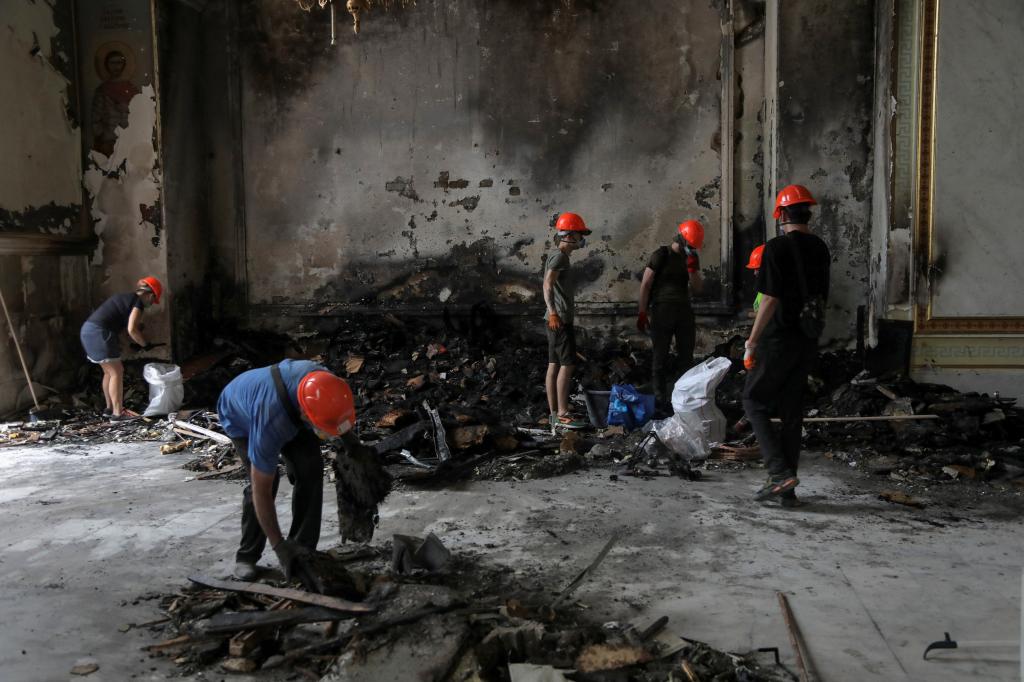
[637,220,703,414]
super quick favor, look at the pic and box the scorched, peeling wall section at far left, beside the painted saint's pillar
[0,0,89,418]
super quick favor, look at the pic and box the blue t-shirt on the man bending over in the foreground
[217,359,324,474]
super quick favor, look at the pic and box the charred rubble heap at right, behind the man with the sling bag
[717,337,1024,481]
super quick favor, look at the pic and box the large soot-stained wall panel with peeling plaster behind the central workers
[237,0,731,308]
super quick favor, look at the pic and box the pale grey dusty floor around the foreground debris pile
[0,443,1024,682]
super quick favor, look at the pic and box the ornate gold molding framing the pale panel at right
[913,0,1024,334]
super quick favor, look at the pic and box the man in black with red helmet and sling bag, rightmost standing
[743,184,831,507]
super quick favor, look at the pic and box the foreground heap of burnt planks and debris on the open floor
[136,537,793,682]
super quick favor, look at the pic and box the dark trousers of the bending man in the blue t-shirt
[231,429,324,563]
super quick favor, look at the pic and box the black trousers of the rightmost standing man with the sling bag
[743,335,817,478]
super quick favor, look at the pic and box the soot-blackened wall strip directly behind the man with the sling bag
[777,0,874,339]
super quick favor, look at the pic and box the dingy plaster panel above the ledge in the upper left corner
[0,0,82,219]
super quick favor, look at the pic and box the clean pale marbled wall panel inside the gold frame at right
[931,0,1024,317]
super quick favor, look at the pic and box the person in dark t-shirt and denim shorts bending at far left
[79,278,164,422]
